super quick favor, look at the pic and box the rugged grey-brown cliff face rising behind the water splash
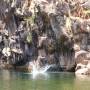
[0,0,90,71]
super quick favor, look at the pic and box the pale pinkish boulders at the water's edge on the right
[75,51,90,75]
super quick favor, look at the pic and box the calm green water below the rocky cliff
[0,70,90,90]
